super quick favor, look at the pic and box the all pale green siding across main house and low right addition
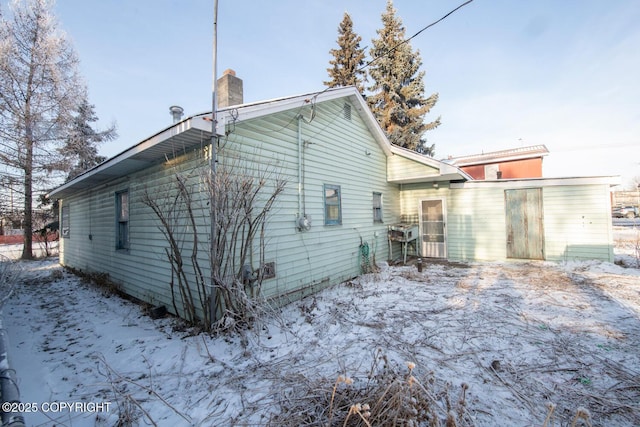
[60,93,613,322]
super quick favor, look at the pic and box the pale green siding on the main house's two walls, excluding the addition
[60,99,400,318]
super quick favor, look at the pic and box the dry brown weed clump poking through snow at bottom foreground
[269,351,474,427]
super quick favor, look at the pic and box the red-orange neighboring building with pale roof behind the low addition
[445,145,549,180]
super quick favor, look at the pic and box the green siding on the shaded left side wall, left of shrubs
[60,150,202,314]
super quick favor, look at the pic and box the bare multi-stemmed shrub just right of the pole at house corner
[204,158,286,330]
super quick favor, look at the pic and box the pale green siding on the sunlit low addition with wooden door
[400,180,613,261]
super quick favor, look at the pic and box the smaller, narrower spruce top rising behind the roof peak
[324,12,367,93]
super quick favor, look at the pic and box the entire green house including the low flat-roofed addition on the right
[50,87,612,322]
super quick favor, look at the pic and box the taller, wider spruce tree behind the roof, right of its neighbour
[367,0,440,156]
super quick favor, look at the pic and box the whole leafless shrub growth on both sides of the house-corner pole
[143,150,286,331]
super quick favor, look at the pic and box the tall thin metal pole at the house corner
[209,0,218,323]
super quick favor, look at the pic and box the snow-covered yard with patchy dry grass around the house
[3,228,640,427]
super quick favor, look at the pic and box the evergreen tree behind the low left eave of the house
[60,98,117,181]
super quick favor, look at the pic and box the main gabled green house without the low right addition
[50,88,466,320]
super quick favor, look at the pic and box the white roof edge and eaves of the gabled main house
[49,86,471,199]
